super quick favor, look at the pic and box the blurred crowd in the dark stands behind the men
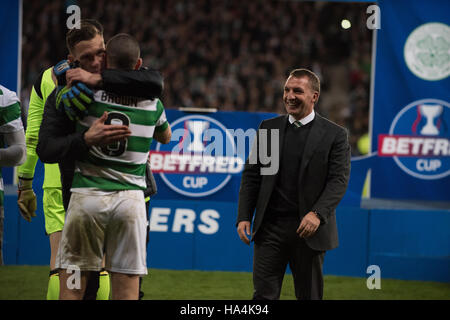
[21,0,372,155]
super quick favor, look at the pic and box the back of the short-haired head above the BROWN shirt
[106,33,141,70]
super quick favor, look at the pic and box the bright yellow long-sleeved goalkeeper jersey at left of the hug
[18,67,61,189]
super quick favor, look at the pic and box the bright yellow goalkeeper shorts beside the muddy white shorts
[42,188,66,234]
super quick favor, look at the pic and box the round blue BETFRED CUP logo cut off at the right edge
[378,99,450,180]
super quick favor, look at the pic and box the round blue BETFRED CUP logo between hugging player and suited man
[150,115,245,197]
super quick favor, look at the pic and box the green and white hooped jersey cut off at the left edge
[0,85,23,205]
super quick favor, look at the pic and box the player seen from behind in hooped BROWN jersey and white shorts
[56,34,171,299]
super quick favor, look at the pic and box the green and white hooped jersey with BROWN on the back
[71,90,169,192]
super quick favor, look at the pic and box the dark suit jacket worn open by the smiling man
[237,113,350,251]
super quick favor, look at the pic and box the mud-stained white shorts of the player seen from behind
[56,190,148,275]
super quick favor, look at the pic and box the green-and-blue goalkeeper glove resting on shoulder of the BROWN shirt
[56,82,94,121]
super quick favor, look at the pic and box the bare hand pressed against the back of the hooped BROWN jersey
[84,111,131,147]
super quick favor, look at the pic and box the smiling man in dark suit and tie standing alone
[237,69,350,300]
